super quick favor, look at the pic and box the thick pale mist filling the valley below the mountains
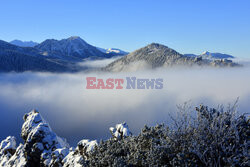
[0,60,250,145]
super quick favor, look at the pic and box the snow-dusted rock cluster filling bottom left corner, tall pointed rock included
[1,110,69,167]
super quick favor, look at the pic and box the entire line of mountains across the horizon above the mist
[0,36,236,72]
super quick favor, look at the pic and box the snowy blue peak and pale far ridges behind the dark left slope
[10,36,128,60]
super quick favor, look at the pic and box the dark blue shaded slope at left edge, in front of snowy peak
[0,40,83,72]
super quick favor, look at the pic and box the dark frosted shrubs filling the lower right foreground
[88,105,250,167]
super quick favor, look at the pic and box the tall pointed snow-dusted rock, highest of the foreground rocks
[21,110,69,166]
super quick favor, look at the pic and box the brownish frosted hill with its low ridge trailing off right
[103,43,238,72]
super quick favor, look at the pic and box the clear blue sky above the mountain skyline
[0,0,250,57]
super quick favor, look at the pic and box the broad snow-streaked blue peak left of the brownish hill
[35,36,110,61]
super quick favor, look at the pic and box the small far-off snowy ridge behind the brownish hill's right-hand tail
[184,51,235,60]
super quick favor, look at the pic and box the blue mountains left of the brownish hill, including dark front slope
[0,36,128,72]
